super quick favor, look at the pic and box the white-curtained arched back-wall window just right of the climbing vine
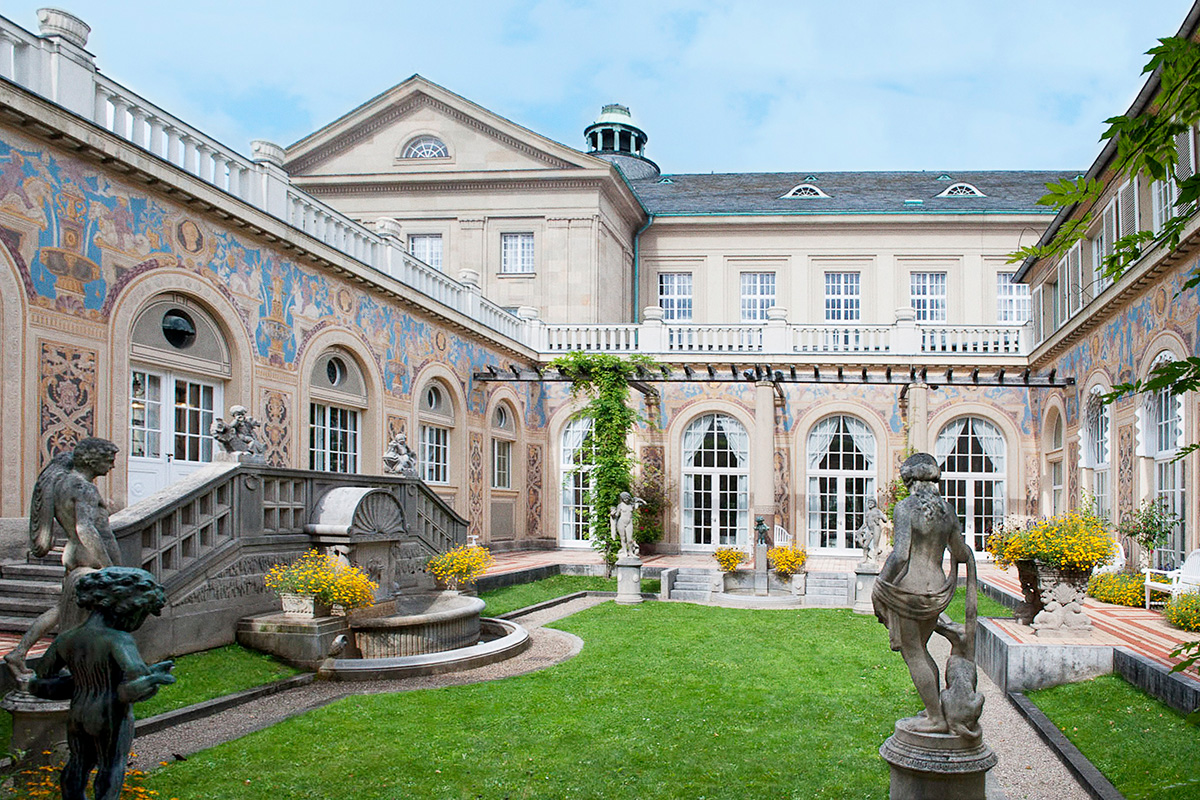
[683,414,750,548]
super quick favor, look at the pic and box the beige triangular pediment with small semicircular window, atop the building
[284,76,607,176]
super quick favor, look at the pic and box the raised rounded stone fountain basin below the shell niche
[350,593,485,658]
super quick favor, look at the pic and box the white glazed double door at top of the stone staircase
[128,368,221,504]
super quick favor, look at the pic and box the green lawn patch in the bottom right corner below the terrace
[1030,675,1200,800]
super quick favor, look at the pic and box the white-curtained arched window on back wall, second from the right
[806,415,875,548]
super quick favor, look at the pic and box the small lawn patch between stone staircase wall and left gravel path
[135,644,301,720]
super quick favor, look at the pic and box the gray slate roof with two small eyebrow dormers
[629,170,1080,215]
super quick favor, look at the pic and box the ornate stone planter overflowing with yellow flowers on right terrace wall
[988,506,1116,627]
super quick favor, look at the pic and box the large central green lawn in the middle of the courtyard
[148,603,919,800]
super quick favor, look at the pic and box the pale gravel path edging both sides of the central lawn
[132,597,1090,800]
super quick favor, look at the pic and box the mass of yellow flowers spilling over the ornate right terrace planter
[988,509,1116,572]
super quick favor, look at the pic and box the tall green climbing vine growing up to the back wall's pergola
[550,350,654,566]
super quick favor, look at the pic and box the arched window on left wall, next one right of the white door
[308,349,367,473]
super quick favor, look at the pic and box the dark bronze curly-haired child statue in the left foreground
[31,566,175,800]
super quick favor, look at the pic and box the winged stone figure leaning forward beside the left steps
[4,437,121,682]
